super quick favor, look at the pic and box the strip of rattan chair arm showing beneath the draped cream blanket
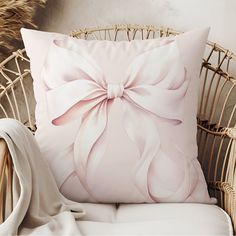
[0,139,13,224]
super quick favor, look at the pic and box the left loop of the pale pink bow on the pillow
[42,40,106,125]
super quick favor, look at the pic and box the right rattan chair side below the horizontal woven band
[198,124,236,233]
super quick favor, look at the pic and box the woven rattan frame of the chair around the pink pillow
[0,25,236,231]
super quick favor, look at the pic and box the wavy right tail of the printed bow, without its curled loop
[123,100,160,201]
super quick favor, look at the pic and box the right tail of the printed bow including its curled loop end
[123,100,196,202]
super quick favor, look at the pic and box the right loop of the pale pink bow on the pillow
[125,42,189,124]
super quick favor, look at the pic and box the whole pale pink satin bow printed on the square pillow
[44,41,189,198]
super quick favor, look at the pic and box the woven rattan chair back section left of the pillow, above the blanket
[0,49,36,131]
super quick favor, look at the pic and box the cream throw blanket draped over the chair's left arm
[0,119,85,236]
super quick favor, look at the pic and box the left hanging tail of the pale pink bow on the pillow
[74,100,107,200]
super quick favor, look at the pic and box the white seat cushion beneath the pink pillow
[78,203,233,235]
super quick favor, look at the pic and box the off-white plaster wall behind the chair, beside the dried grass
[37,0,236,52]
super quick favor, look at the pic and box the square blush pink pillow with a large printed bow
[22,29,214,203]
